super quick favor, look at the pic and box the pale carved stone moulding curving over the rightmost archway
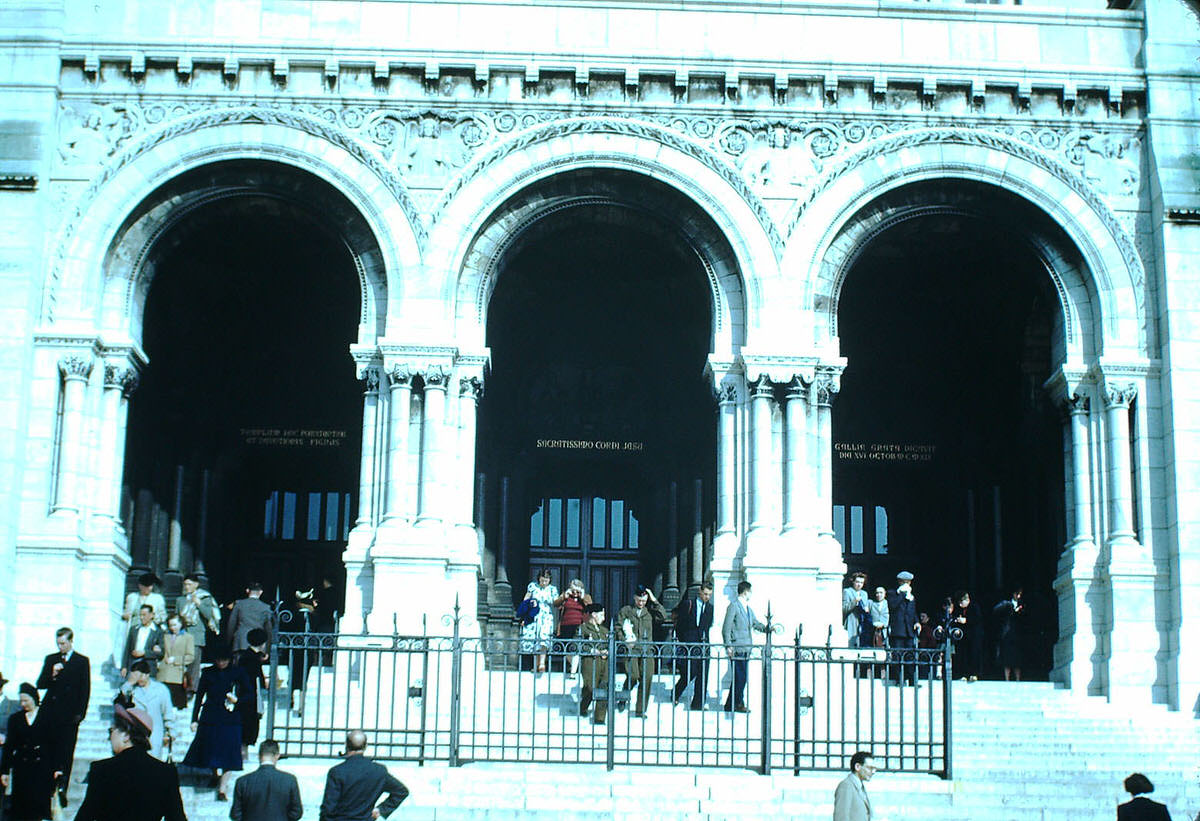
[784,128,1146,361]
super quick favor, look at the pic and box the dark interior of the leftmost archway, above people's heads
[125,196,361,612]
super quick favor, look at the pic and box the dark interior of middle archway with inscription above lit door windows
[480,204,715,607]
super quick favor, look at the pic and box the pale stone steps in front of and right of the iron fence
[60,682,1200,821]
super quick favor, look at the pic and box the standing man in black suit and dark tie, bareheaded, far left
[37,628,91,785]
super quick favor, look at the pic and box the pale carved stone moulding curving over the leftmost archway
[41,108,425,338]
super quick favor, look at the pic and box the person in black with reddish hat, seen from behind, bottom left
[76,705,187,821]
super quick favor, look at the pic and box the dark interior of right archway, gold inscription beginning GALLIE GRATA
[833,212,1064,678]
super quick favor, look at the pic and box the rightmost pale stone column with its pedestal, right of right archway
[1104,379,1159,703]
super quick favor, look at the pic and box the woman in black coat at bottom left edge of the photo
[0,683,54,821]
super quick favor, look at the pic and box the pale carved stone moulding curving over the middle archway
[424,120,779,347]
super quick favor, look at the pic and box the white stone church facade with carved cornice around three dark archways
[0,0,1200,711]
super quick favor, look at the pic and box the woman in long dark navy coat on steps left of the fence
[184,646,253,801]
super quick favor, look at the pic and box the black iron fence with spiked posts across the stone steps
[265,616,952,778]
